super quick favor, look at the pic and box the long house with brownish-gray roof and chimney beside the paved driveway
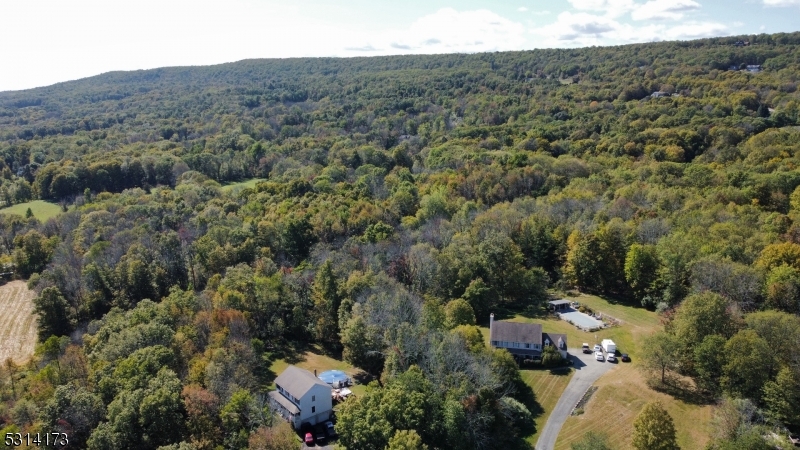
[489,314,567,360]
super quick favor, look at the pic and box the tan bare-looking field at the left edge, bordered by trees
[0,280,36,364]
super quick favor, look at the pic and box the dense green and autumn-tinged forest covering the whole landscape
[0,29,800,450]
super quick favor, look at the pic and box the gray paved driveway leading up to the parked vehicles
[535,348,619,450]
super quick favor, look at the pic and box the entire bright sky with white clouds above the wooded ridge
[0,0,800,91]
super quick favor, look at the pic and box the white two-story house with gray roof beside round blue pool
[269,366,333,428]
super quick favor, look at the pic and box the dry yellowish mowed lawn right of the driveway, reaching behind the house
[556,295,712,450]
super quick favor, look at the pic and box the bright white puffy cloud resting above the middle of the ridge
[346,8,525,55]
